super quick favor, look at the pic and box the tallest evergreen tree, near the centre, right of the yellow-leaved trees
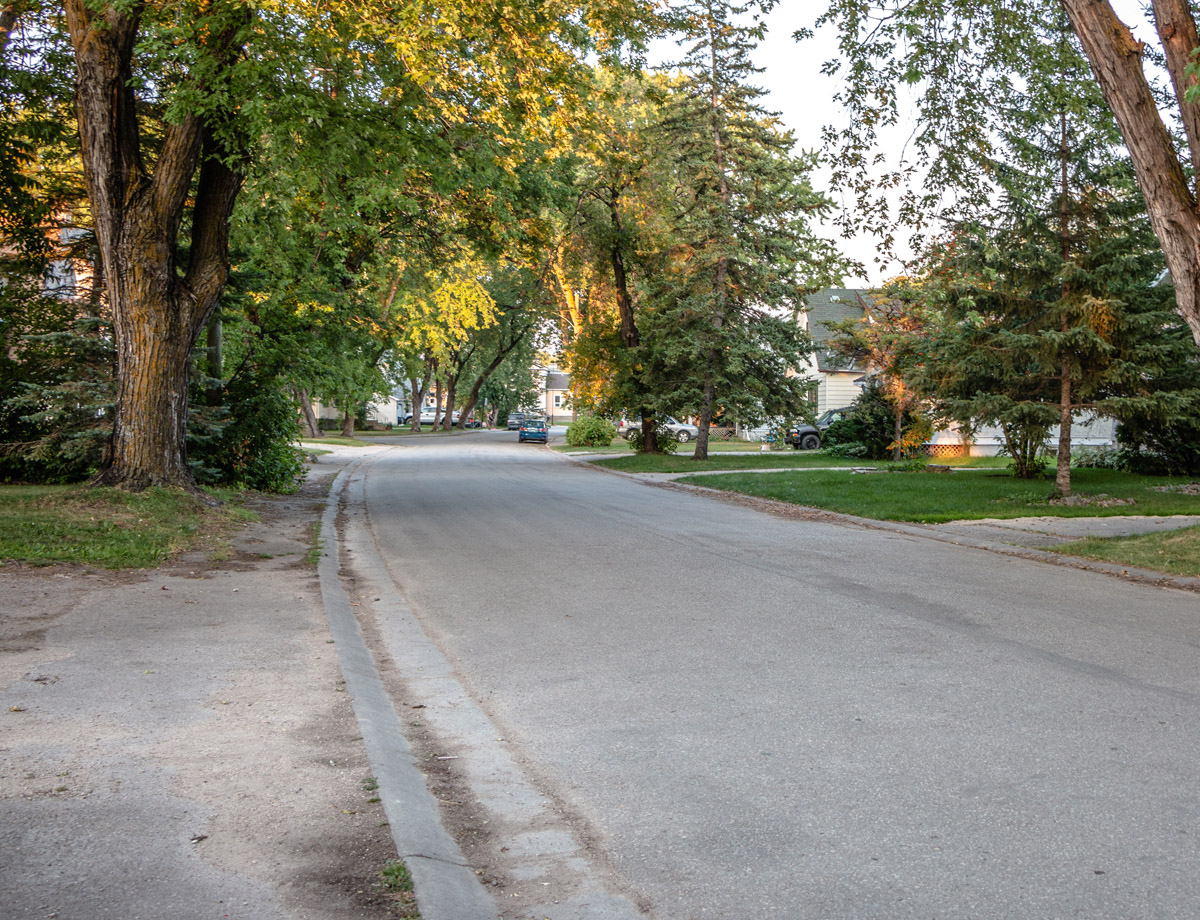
[640,0,841,459]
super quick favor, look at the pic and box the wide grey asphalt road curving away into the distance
[348,432,1200,920]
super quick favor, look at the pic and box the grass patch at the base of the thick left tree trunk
[0,486,248,569]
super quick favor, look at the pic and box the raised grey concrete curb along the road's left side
[317,457,497,920]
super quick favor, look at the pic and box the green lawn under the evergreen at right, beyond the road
[682,469,1200,523]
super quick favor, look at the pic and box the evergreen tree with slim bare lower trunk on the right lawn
[914,8,1181,498]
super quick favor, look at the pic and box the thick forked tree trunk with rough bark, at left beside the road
[65,0,241,491]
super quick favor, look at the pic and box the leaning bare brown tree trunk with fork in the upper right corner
[1063,0,1200,345]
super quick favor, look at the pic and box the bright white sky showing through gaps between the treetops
[650,0,1154,287]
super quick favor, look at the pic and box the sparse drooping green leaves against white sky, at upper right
[816,0,1111,252]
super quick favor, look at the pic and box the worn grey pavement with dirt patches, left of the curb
[0,451,404,920]
